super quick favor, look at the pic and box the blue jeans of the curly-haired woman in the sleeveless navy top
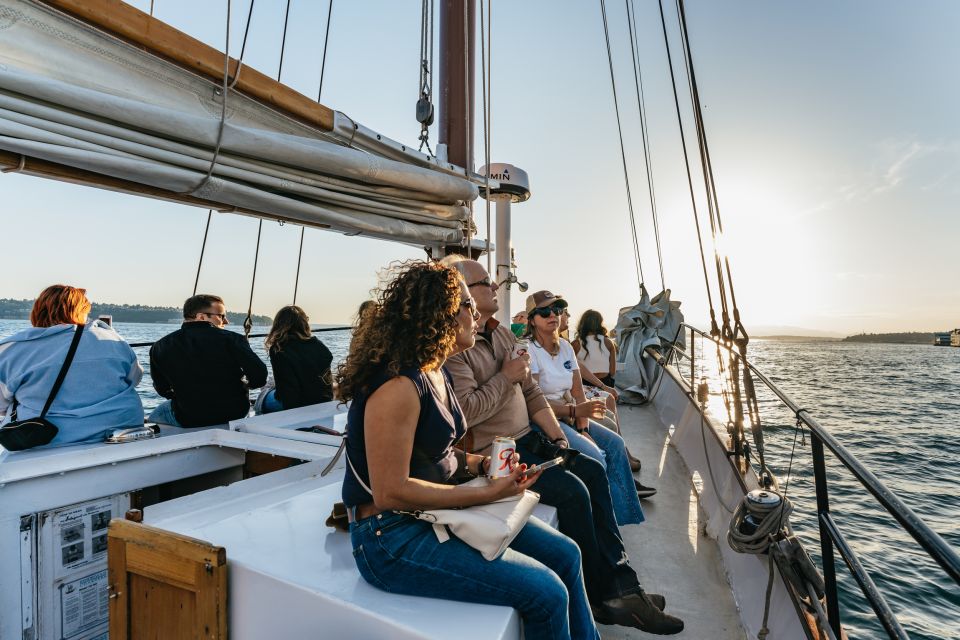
[350,511,600,640]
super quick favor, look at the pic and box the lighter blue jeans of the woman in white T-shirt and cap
[560,420,646,527]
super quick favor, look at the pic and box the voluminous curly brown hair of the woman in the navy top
[336,260,461,402]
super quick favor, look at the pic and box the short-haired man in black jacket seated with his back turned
[147,294,267,427]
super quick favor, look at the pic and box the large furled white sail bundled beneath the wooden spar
[0,0,478,245]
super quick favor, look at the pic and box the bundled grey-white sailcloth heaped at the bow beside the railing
[615,285,686,404]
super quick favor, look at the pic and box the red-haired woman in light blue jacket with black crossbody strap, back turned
[0,284,143,446]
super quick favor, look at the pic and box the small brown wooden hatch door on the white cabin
[107,519,227,640]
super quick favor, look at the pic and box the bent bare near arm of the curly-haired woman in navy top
[363,377,536,509]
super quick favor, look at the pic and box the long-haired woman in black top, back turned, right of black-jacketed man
[262,305,333,413]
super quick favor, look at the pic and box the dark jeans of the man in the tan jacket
[517,430,639,604]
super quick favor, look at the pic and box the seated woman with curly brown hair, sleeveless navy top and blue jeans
[337,262,600,639]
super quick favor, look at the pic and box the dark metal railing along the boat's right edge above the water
[647,324,960,639]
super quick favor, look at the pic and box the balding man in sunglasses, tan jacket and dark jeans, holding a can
[441,256,683,634]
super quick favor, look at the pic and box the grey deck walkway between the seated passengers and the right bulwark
[601,405,747,640]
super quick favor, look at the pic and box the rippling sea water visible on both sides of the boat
[0,320,960,640]
